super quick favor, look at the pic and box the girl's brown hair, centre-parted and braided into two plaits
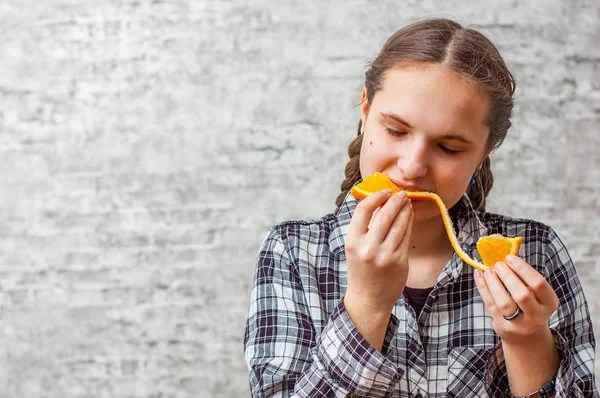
[335,19,516,218]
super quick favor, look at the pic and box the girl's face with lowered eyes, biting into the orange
[360,64,489,223]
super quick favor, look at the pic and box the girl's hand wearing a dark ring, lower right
[475,256,558,344]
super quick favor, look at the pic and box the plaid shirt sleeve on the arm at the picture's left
[244,229,403,398]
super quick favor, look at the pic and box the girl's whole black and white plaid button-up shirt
[244,191,598,398]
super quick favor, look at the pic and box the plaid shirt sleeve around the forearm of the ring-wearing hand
[486,230,598,398]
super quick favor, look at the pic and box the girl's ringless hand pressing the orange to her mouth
[344,189,414,319]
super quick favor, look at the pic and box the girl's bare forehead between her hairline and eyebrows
[372,65,489,137]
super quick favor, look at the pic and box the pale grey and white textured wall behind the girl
[0,0,600,398]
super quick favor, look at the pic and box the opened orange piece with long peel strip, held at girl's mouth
[350,172,521,271]
